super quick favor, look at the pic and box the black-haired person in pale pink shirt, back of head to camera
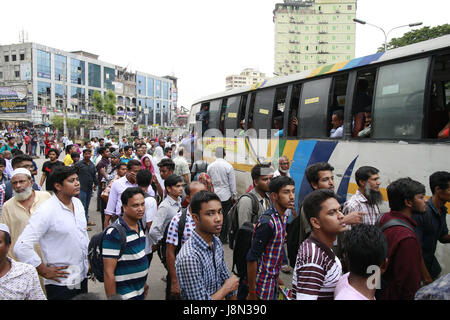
[334,224,388,300]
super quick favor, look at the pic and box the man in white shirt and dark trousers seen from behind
[207,147,237,243]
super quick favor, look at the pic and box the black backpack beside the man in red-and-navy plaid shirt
[231,213,272,280]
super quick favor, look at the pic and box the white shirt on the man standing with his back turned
[207,158,237,202]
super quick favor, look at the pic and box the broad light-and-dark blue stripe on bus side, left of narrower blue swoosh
[291,141,337,212]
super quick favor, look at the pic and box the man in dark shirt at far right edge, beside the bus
[413,171,450,282]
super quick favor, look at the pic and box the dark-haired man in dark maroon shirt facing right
[377,178,426,300]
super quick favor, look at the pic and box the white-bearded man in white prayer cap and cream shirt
[0,168,51,290]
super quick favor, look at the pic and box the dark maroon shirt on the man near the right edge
[380,211,422,300]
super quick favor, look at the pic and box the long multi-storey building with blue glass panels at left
[0,43,176,125]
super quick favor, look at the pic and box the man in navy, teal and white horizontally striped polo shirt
[102,188,149,300]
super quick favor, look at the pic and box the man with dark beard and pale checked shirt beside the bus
[342,166,383,227]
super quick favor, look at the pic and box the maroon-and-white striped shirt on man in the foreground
[291,236,342,300]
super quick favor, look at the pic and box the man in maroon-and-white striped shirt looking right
[290,189,346,300]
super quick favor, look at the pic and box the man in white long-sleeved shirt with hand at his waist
[14,166,89,300]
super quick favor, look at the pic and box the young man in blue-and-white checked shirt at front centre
[175,191,239,300]
